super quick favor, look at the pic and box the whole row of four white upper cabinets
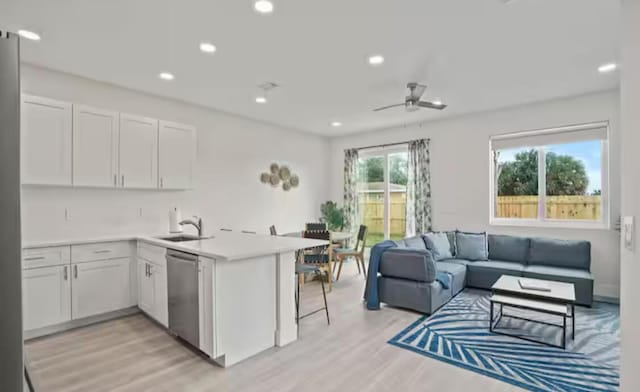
[21,94,196,189]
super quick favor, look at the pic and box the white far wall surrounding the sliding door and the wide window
[330,91,620,297]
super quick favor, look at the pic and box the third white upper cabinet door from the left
[119,114,158,188]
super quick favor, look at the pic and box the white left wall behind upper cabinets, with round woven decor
[22,65,329,243]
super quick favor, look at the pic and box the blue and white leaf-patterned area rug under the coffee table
[389,290,620,392]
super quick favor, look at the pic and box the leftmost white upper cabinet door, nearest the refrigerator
[20,95,72,185]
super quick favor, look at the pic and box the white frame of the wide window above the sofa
[489,121,611,230]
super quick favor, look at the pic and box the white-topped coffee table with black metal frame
[489,275,576,349]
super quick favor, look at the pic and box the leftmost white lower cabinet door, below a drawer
[22,265,71,331]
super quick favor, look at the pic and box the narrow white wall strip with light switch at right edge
[620,0,640,392]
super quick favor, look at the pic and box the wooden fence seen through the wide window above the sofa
[496,196,602,220]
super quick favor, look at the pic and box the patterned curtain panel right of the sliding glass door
[406,139,431,237]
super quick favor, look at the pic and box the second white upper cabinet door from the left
[73,105,119,187]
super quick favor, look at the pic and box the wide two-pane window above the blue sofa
[491,123,608,227]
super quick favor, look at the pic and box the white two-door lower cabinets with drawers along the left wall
[22,241,136,336]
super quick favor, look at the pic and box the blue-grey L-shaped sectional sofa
[378,232,593,314]
